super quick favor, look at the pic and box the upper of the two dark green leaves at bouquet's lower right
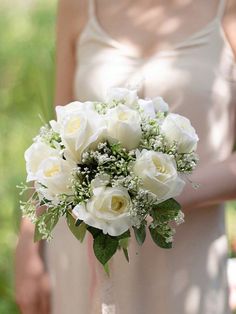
[151,198,181,223]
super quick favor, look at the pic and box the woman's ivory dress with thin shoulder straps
[46,0,236,314]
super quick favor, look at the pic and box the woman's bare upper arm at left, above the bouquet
[55,0,88,105]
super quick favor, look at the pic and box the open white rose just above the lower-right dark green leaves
[133,150,185,201]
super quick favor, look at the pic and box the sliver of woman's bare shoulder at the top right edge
[223,0,236,57]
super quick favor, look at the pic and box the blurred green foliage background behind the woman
[0,0,236,314]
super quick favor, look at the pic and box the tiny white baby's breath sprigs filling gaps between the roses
[20,92,198,248]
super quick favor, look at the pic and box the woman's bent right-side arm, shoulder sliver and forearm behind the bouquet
[177,0,236,210]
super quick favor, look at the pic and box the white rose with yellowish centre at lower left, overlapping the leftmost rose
[36,157,75,199]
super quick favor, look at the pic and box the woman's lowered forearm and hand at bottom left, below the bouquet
[15,220,50,314]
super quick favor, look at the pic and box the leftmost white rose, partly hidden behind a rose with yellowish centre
[25,141,59,182]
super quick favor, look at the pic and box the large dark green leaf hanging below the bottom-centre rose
[93,233,118,265]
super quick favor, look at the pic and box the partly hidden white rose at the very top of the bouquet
[106,87,138,107]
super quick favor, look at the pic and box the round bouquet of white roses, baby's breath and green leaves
[21,88,198,271]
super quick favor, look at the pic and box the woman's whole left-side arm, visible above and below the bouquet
[15,0,87,314]
